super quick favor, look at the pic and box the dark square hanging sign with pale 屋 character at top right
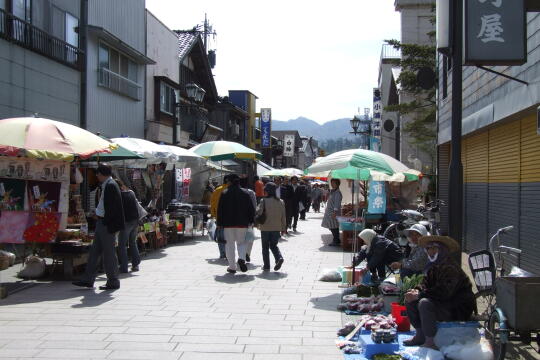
[463,0,527,65]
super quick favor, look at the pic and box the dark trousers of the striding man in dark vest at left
[81,219,120,287]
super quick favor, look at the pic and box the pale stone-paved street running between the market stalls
[0,214,343,360]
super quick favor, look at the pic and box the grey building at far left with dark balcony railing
[0,0,83,126]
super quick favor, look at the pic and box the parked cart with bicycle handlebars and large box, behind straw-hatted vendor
[469,226,540,360]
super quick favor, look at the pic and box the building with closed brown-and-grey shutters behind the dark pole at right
[438,9,540,273]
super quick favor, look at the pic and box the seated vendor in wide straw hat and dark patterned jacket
[404,236,476,349]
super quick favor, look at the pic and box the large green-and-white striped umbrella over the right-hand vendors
[305,149,421,182]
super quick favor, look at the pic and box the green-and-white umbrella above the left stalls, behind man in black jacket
[191,141,262,161]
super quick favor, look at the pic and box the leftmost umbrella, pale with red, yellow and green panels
[0,117,116,161]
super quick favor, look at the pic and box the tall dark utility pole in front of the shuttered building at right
[448,1,463,252]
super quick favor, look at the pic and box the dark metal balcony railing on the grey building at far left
[0,9,83,70]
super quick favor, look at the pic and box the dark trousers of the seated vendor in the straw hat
[405,298,452,339]
